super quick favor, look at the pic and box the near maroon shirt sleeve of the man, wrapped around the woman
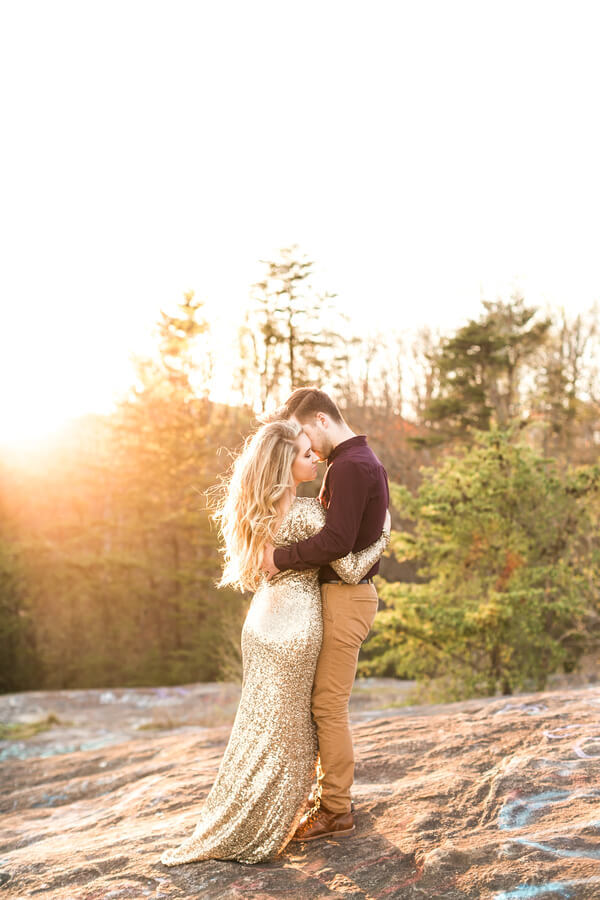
[273,459,369,572]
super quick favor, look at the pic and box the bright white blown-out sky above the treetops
[0,0,600,440]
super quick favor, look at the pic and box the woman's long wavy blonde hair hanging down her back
[212,420,301,591]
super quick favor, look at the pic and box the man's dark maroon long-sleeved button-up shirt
[273,434,390,581]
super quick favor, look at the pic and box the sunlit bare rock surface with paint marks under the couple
[0,682,600,900]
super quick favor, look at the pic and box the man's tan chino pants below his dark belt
[312,583,377,813]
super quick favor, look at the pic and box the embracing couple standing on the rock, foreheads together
[161,388,390,866]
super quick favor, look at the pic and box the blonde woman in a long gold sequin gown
[161,421,389,866]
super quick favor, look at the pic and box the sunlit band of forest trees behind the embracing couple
[0,247,600,700]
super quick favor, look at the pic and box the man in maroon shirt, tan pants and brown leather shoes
[263,388,389,840]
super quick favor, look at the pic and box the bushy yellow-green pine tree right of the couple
[362,428,600,700]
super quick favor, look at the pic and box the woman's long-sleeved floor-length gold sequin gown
[161,497,389,866]
